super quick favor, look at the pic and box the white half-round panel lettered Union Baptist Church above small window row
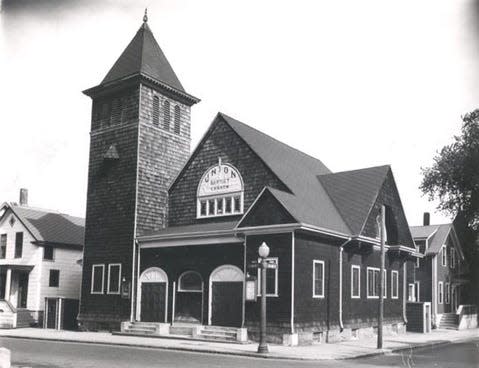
[198,159,243,197]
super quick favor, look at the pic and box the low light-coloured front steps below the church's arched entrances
[120,322,248,343]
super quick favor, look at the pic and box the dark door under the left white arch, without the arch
[141,282,166,322]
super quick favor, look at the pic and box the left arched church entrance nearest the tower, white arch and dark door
[137,267,168,322]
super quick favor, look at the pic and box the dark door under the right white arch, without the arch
[211,281,243,327]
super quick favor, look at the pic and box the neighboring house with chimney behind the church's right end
[408,213,467,327]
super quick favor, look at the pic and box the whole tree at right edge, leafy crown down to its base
[420,109,479,304]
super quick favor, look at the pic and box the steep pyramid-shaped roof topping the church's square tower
[101,21,185,92]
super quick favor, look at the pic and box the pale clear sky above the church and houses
[0,0,479,225]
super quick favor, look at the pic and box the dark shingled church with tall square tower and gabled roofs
[79,12,416,344]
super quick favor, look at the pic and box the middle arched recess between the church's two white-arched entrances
[175,271,203,323]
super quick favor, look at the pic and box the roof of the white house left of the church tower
[3,203,85,246]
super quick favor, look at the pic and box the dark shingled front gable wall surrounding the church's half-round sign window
[168,121,286,226]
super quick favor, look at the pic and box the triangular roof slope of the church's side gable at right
[318,165,391,234]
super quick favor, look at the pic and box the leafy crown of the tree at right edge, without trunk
[420,109,479,231]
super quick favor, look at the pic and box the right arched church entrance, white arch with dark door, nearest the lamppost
[208,265,244,327]
